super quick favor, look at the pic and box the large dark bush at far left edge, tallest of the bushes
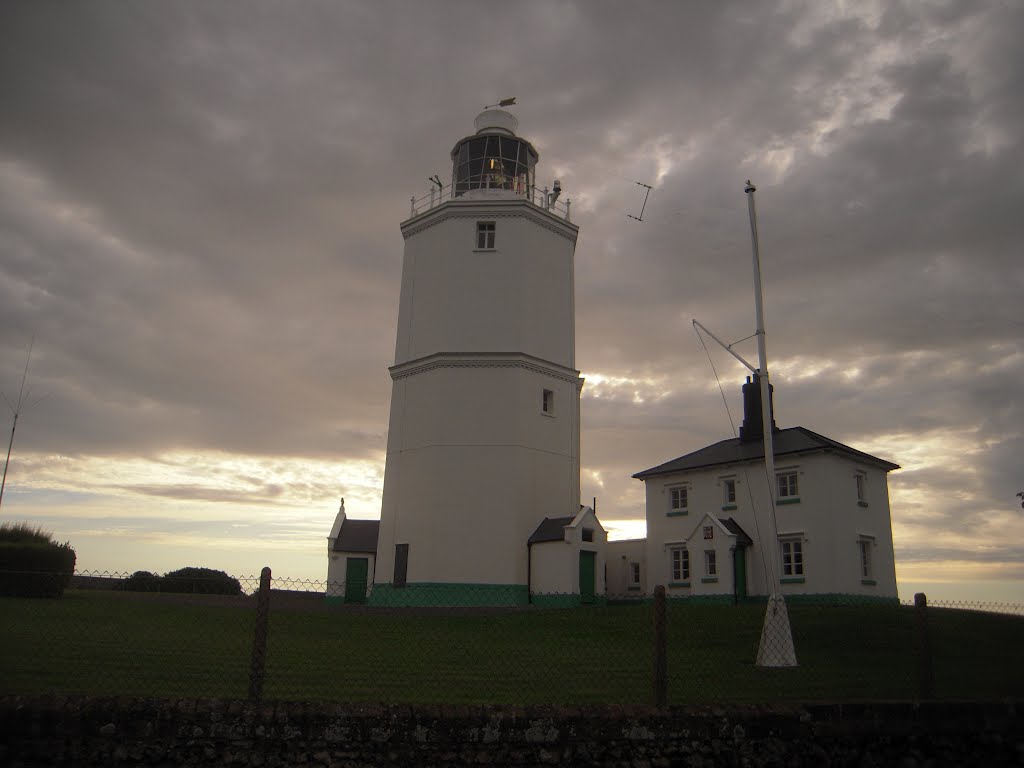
[0,522,77,597]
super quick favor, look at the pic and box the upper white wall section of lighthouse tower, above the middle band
[395,198,577,369]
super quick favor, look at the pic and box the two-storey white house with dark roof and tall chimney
[608,377,899,599]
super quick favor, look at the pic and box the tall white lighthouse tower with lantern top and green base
[370,110,603,604]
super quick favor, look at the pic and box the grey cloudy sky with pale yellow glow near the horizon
[0,0,1024,602]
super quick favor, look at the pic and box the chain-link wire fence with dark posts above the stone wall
[0,569,1024,705]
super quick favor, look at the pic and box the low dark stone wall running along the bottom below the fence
[0,696,1024,768]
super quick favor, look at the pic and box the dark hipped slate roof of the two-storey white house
[633,427,899,480]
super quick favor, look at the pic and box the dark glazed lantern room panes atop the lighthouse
[452,133,537,197]
